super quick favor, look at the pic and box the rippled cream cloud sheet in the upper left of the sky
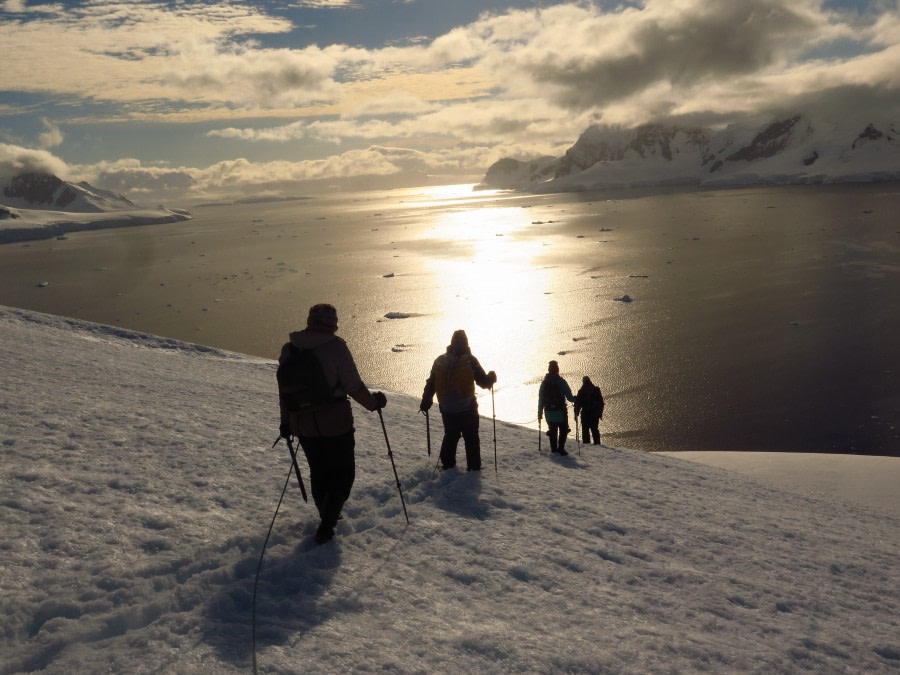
[0,2,296,107]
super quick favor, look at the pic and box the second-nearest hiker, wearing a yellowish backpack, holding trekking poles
[419,330,497,471]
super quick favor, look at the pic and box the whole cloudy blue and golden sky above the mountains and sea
[0,0,900,205]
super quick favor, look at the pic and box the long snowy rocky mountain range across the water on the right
[479,115,900,192]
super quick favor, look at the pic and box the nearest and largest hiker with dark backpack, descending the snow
[278,304,387,544]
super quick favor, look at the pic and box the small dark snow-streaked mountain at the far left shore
[0,173,137,213]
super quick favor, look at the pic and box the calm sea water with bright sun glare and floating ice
[0,184,900,454]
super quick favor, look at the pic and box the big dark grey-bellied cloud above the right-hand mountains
[471,0,826,110]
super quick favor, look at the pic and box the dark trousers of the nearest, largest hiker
[300,431,356,533]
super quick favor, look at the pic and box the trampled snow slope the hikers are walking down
[0,307,900,675]
